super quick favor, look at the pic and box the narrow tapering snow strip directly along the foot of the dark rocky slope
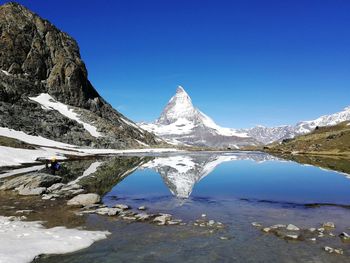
[0,127,77,148]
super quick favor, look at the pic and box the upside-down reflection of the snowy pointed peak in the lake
[143,153,277,198]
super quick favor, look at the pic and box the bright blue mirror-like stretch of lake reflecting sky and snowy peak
[108,154,350,204]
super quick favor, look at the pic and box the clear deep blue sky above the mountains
[1,0,350,128]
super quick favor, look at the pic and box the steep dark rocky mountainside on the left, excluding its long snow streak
[0,3,156,148]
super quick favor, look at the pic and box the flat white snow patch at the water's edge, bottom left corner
[0,216,109,263]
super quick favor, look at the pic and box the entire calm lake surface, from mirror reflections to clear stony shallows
[26,153,350,262]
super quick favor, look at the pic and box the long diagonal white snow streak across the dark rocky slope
[29,93,102,137]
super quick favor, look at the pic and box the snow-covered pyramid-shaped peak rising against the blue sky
[140,86,256,149]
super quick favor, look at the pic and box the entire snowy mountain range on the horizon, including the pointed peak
[139,86,350,149]
